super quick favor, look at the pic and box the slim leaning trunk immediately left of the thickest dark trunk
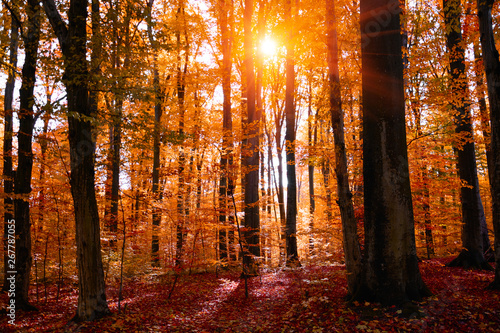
[326,0,361,294]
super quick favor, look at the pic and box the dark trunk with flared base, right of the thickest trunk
[443,0,491,269]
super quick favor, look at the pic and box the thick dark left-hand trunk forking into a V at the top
[43,0,110,321]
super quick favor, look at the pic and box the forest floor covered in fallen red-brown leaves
[0,258,500,332]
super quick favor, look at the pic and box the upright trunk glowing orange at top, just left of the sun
[242,0,260,276]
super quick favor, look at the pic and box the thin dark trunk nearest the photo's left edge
[2,11,19,291]
